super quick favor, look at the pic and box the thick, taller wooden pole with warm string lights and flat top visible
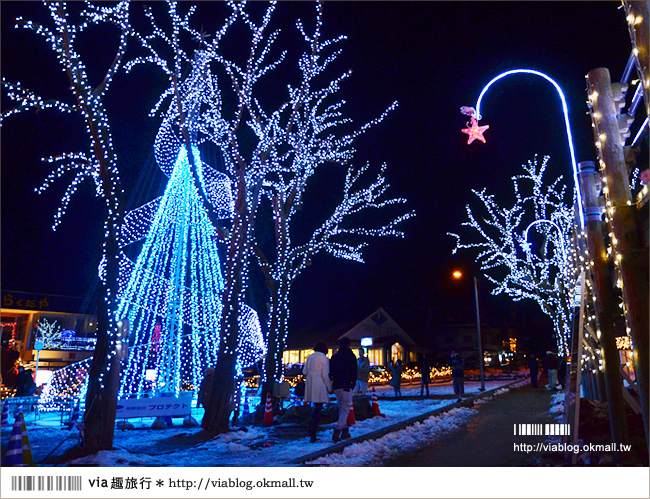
[587,68,650,452]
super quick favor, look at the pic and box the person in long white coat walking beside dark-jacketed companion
[302,341,332,443]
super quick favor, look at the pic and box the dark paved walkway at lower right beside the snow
[386,386,555,467]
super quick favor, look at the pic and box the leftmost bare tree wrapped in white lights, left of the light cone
[2,2,131,453]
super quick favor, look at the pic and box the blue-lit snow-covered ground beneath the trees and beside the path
[2,380,512,467]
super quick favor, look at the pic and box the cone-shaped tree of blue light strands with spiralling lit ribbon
[116,46,264,396]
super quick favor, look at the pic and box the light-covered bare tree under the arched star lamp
[450,156,576,355]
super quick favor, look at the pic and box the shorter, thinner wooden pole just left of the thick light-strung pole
[578,161,629,450]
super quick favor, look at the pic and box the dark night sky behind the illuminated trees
[0,1,641,350]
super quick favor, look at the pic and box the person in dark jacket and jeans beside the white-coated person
[330,337,357,442]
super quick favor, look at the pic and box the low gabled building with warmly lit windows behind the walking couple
[283,308,422,366]
